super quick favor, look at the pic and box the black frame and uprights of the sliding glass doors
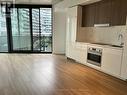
[6,4,53,53]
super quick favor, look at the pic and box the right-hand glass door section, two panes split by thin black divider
[32,8,52,52]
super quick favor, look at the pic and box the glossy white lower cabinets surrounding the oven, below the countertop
[66,42,123,79]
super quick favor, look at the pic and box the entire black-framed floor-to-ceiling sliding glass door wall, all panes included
[0,5,52,53]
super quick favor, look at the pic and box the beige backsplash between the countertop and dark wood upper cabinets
[77,26,127,45]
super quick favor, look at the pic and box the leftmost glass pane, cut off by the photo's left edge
[0,8,8,52]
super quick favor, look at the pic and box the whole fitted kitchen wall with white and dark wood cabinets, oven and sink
[53,0,127,80]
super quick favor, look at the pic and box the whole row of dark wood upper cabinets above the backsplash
[82,0,127,27]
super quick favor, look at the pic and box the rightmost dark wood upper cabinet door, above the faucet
[111,0,127,26]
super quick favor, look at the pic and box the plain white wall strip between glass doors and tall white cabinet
[53,6,66,54]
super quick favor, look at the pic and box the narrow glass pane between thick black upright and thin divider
[32,9,40,51]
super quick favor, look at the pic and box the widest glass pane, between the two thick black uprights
[11,8,31,50]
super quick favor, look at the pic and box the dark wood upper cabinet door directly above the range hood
[95,0,111,24]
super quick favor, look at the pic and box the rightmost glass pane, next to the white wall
[40,8,52,52]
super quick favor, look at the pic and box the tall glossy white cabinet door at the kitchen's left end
[66,6,78,59]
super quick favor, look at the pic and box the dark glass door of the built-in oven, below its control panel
[87,52,101,66]
